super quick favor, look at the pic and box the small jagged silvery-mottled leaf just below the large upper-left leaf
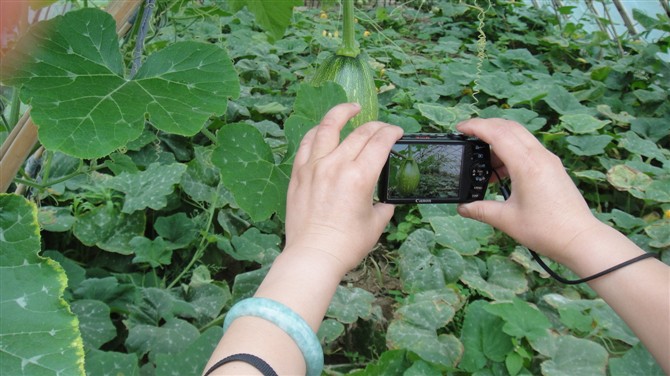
[104,163,186,213]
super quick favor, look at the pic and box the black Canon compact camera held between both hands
[377,133,492,204]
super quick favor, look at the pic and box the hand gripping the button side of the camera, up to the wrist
[457,119,603,263]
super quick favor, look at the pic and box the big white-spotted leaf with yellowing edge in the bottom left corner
[0,194,84,375]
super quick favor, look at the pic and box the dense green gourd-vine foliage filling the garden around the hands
[0,0,670,375]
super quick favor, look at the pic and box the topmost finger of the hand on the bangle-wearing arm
[310,103,361,160]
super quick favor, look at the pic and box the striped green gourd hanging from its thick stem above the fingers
[311,0,379,128]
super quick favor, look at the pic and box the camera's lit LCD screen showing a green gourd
[388,143,464,200]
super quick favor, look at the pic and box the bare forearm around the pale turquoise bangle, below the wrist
[207,250,343,375]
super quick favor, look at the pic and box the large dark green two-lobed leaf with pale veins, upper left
[0,8,240,158]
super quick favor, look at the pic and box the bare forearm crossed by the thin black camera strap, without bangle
[565,224,670,374]
